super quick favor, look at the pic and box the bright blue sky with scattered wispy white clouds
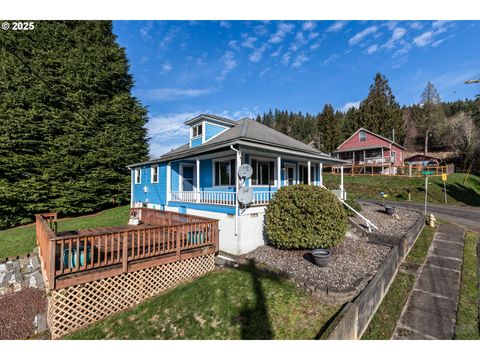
[114,21,480,156]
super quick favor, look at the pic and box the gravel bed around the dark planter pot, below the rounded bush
[244,232,390,290]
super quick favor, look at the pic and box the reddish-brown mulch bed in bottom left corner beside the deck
[0,288,47,340]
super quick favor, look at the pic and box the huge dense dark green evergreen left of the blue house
[0,21,148,228]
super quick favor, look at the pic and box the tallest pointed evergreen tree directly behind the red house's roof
[358,73,405,143]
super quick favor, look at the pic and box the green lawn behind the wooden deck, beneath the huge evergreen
[0,206,130,259]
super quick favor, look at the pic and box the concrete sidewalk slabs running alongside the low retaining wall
[392,224,464,340]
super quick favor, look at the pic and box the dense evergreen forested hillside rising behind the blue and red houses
[256,74,480,170]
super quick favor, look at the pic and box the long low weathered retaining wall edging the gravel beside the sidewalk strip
[326,215,425,340]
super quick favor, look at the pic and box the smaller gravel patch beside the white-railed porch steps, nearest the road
[354,203,422,236]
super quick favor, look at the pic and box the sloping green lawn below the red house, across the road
[323,173,480,206]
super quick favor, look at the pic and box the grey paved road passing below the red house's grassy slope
[361,200,480,233]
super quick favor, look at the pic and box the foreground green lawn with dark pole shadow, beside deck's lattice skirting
[67,266,338,339]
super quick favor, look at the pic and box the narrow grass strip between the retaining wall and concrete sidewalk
[362,227,435,340]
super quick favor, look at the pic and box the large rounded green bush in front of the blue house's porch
[265,185,347,249]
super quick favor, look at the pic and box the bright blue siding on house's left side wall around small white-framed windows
[132,162,167,205]
